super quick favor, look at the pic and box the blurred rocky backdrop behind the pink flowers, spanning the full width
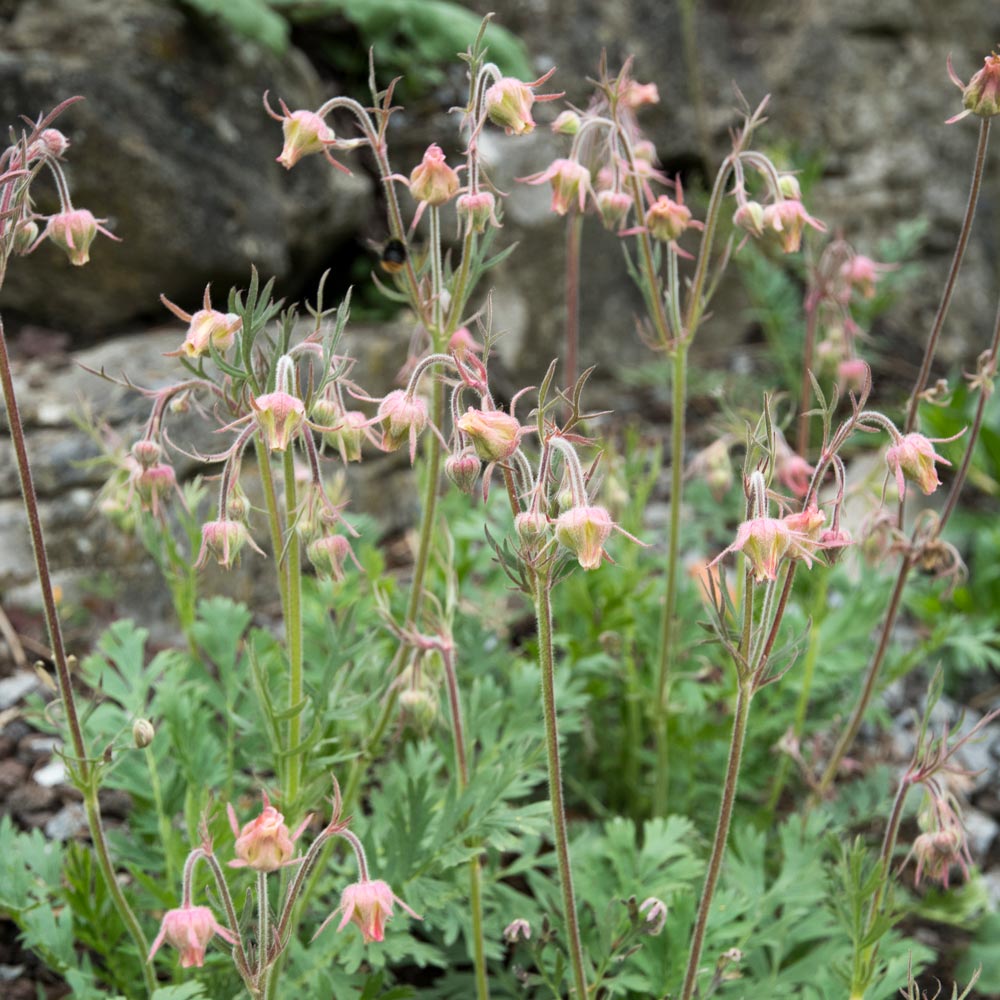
[0,0,1000,632]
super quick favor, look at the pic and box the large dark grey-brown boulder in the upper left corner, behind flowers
[0,0,371,334]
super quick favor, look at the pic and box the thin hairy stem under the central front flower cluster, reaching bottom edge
[531,568,589,1000]
